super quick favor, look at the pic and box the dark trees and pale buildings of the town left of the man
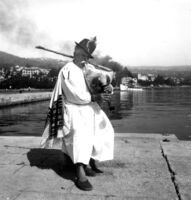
[0,65,57,89]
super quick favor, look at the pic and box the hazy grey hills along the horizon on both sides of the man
[0,51,191,76]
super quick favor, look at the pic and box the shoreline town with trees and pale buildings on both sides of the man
[0,64,191,89]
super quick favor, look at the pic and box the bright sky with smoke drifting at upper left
[0,0,191,66]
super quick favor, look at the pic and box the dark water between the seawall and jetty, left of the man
[0,101,49,136]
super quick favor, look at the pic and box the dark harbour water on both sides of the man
[0,87,191,140]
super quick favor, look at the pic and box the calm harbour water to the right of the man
[111,88,191,140]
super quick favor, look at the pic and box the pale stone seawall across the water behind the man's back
[0,92,52,107]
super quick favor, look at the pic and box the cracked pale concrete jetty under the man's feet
[0,133,191,200]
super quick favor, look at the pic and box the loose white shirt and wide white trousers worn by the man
[41,62,114,164]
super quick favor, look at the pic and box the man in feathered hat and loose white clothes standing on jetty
[41,38,114,191]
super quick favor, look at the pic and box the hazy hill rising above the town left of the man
[0,51,67,69]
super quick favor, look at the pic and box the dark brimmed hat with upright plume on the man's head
[75,37,96,58]
